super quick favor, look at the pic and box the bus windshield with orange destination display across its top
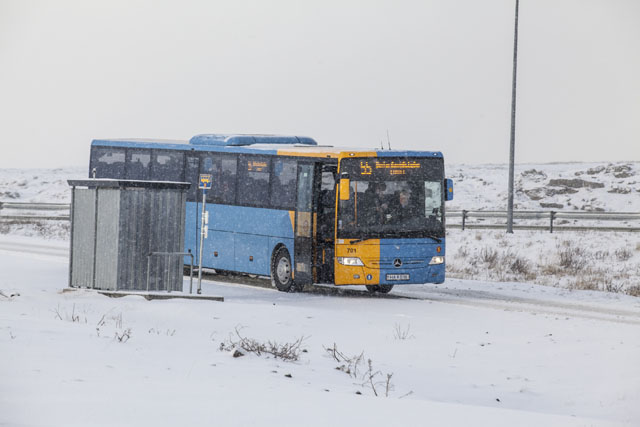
[338,157,444,239]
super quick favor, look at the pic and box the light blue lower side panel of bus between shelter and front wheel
[185,202,294,276]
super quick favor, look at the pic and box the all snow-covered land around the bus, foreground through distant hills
[0,163,640,426]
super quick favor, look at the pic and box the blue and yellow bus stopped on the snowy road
[89,134,453,293]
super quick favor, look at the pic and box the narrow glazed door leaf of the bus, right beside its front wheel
[294,163,315,285]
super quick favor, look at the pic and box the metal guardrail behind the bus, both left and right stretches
[0,202,640,233]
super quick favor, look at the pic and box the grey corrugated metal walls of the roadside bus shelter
[70,182,186,291]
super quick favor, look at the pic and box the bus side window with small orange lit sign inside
[238,156,271,207]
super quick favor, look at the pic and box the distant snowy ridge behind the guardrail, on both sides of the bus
[0,162,640,212]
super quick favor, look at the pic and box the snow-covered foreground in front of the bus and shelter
[0,236,640,426]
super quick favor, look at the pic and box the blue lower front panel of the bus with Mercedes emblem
[380,239,446,285]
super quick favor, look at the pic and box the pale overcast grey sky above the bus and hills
[0,0,640,167]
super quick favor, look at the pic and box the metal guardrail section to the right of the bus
[446,209,640,233]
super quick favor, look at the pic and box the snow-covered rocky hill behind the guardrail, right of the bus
[447,162,640,212]
